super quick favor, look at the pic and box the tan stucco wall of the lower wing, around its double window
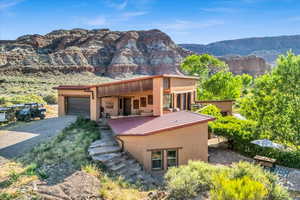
[119,123,208,170]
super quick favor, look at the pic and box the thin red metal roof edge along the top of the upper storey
[53,74,199,90]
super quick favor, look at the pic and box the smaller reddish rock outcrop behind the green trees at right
[219,56,271,77]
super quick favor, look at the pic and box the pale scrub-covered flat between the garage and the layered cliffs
[0,72,113,105]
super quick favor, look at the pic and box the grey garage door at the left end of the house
[66,97,90,118]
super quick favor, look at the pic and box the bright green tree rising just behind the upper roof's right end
[180,54,228,79]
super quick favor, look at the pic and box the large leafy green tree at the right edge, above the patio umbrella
[240,52,300,149]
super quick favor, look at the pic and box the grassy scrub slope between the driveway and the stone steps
[0,118,100,199]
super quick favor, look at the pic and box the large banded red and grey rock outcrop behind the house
[0,29,189,76]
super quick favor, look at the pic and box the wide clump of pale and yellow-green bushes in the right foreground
[165,161,289,200]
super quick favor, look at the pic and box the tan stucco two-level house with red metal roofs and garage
[56,75,214,171]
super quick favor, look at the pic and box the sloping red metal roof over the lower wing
[108,111,214,136]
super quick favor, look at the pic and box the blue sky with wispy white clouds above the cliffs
[0,0,300,44]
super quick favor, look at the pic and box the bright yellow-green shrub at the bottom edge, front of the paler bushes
[210,173,267,200]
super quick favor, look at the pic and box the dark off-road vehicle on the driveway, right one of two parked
[16,103,46,122]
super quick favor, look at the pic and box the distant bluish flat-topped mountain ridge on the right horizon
[179,35,300,65]
